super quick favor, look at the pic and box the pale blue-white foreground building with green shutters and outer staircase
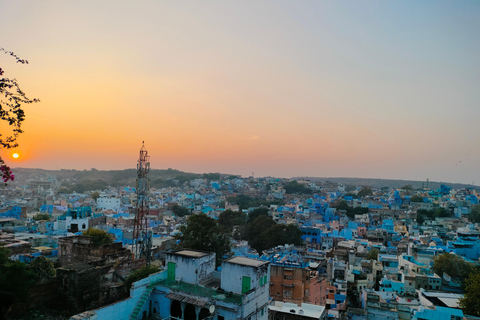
[71,250,270,320]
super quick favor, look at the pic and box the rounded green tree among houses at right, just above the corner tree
[433,253,473,281]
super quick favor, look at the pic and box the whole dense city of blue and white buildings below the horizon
[0,156,480,320]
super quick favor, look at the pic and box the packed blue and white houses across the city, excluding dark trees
[0,170,480,320]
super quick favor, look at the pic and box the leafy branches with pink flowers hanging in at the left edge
[0,48,39,185]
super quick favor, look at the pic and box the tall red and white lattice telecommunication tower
[133,142,153,264]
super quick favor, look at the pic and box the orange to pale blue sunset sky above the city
[0,0,480,185]
